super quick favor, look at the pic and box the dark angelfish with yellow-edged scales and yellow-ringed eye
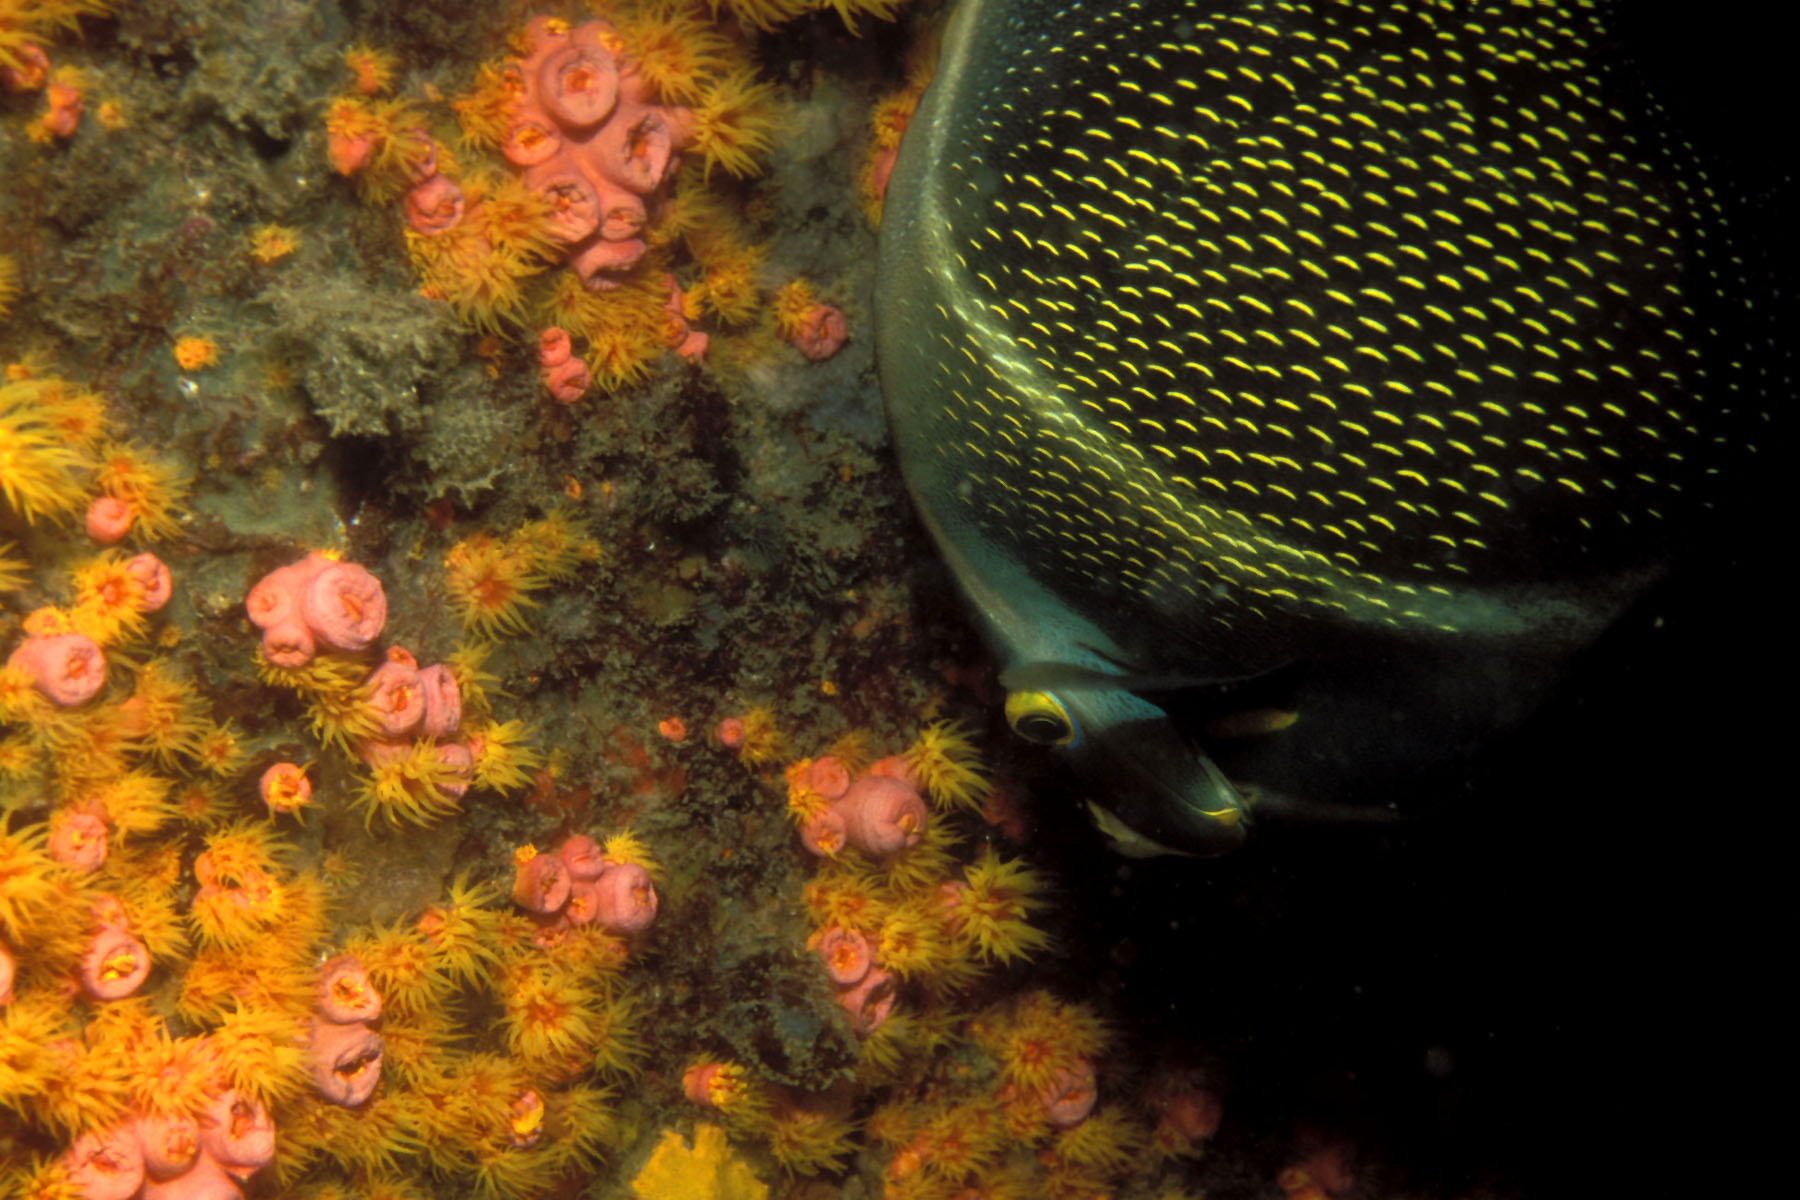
[875,0,1791,856]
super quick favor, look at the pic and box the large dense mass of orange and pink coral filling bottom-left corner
[0,521,648,1196]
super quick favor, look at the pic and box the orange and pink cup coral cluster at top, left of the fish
[315,0,788,398]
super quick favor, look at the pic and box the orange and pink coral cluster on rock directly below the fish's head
[684,721,1220,1200]
